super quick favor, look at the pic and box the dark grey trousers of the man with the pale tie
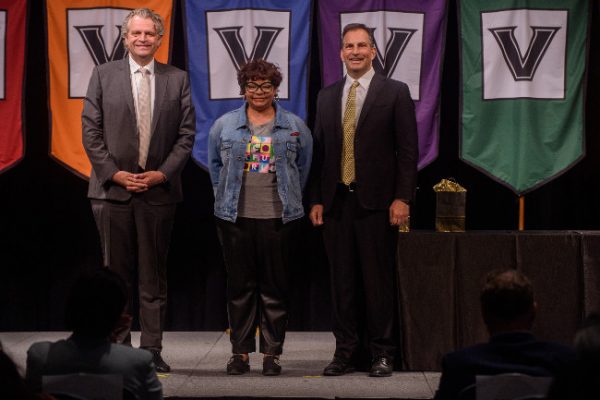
[91,196,176,351]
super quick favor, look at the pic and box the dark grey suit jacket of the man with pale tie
[82,57,195,204]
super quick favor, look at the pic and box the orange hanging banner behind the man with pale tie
[46,0,173,177]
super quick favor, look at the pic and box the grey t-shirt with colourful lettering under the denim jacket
[238,120,283,219]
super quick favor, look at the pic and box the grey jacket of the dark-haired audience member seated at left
[25,336,163,400]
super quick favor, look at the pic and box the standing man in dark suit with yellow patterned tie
[309,24,418,377]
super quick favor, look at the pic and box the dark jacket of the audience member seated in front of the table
[434,332,575,400]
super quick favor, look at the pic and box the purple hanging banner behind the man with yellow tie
[319,0,447,169]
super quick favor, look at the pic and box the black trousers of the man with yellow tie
[323,185,397,359]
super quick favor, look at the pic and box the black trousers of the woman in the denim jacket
[216,218,297,355]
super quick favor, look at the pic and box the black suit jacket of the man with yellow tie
[309,74,418,211]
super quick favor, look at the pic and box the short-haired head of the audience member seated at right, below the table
[480,269,537,334]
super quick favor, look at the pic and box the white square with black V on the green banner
[481,9,568,100]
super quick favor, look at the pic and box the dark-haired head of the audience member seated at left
[66,268,127,338]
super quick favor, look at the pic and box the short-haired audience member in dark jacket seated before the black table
[434,270,575,400]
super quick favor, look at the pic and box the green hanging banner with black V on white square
[458,0,591,195]
